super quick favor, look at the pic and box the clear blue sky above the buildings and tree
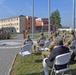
[0,0,76,27]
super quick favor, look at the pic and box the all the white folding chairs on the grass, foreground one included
[18,40,76,75]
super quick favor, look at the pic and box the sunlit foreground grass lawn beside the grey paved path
[10,52,76,75]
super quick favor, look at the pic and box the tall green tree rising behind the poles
[50,9,61,28]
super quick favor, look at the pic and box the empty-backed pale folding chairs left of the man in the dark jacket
[19,40,50,56]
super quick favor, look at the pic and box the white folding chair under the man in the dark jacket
[50,52,71,75]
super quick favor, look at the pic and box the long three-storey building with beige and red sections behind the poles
[0,15,56,33]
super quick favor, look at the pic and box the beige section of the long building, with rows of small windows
[0,15,25,33]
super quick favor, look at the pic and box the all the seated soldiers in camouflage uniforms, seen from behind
[23,30,76,60]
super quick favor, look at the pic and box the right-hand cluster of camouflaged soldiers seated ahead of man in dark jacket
[38,30,76,59]
